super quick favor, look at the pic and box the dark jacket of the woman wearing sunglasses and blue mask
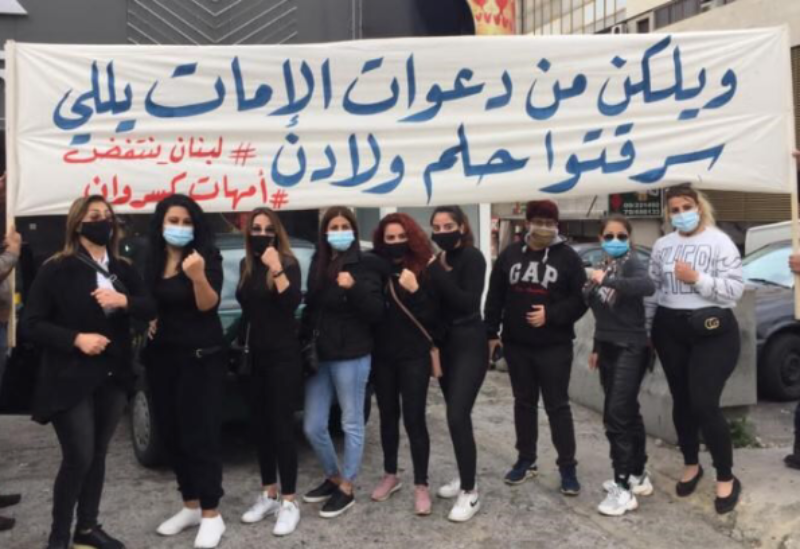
[584,253,656,345]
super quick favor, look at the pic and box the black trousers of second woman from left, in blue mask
[147,349,227,510]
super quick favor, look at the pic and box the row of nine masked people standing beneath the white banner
[23,188,742,549]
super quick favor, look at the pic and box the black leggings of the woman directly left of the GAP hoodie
[439,321,489,492]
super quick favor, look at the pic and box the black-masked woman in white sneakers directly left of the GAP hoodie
[429,206,489,522]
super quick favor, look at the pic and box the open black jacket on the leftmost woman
[20,251,156,423]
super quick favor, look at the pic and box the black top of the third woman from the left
[236,260,303,350]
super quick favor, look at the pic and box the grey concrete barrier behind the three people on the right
[570,291,757,443]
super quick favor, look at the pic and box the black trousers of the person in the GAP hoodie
[503,343,578,468]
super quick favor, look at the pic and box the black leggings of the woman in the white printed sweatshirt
[653,307,739,482]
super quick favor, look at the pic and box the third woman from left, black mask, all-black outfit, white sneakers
[236,208,303,536]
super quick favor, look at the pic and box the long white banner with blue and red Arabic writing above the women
[7,29,793,216]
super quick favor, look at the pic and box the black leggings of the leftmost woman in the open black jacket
[50,380,127,544]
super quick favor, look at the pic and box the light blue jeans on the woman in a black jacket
[303,355,372,482]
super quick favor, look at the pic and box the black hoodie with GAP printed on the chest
[485,239,586,346]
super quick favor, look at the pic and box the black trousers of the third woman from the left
[250,347,303,496]
